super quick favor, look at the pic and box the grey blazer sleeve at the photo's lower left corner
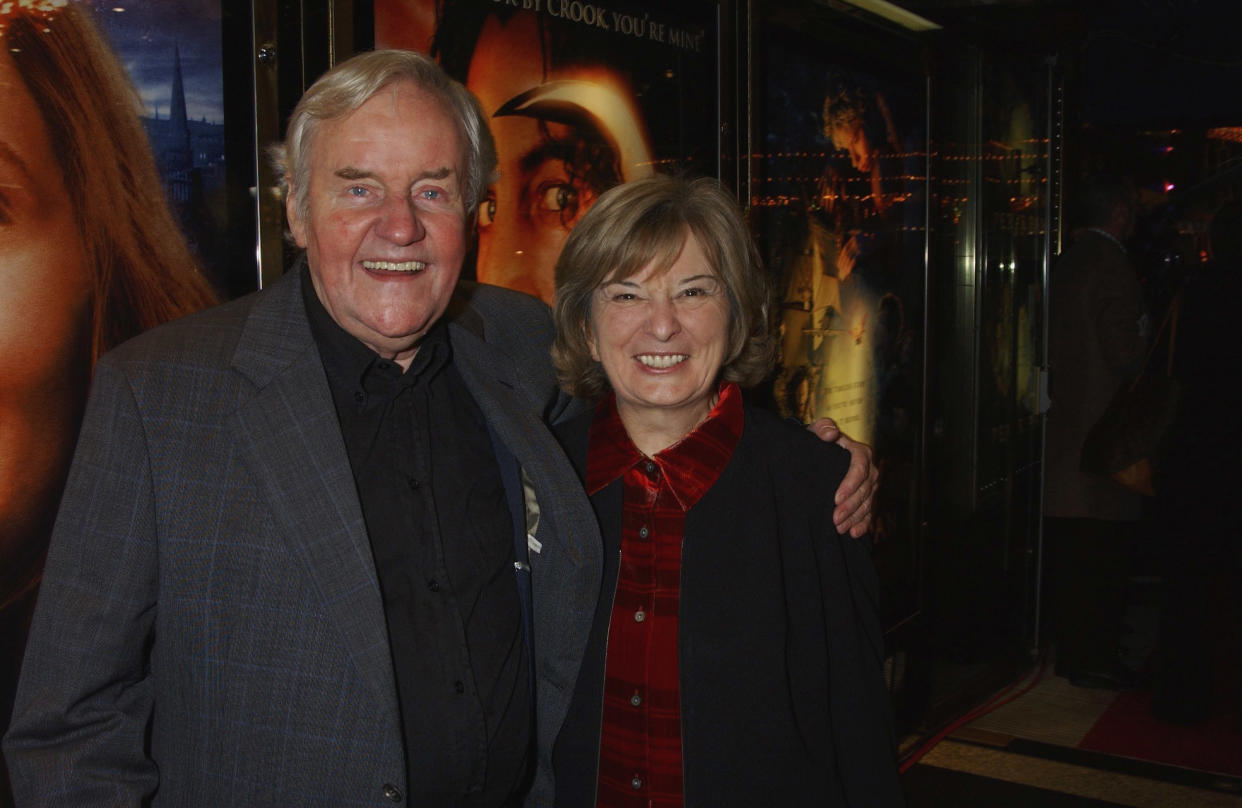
[4,360,158,807]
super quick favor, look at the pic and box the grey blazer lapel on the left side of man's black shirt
[226,268,396,710]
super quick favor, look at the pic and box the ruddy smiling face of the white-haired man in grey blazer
[287,81,467,366]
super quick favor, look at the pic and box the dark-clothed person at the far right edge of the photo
[1151,201,1242,724]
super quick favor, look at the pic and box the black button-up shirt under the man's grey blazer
[302,278,533,807]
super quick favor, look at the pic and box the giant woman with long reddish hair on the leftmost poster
[0,2,215,804]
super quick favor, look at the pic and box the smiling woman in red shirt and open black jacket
[553,177,902,807]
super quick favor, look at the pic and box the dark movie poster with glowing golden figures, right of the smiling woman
[750,22,928,626]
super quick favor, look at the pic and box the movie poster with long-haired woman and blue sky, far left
[0,0,228,806]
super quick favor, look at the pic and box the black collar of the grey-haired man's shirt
[302,264,452,407]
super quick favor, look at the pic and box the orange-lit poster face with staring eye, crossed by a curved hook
[466,14,595,303]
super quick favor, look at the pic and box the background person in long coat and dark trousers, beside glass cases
[1043,173,1148,689]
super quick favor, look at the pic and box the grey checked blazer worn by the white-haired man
[5,272,601,808]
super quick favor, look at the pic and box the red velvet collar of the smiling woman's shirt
[586,382,745,511]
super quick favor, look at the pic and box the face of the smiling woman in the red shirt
[591,236,729,436]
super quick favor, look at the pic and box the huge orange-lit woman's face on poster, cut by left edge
[0,47,92,603]
